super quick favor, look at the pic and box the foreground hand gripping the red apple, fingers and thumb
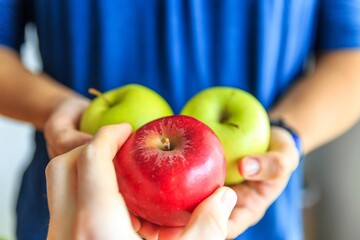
[46,124,236,240]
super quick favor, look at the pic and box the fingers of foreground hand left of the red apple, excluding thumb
[46,124,139,240]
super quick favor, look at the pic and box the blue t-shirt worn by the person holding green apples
[0,0,360,240]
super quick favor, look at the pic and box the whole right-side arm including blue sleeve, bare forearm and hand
[224,0,360,237]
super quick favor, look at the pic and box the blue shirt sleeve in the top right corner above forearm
[317,0,360,51]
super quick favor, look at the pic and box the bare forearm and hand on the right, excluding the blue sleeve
[221,51,360,237]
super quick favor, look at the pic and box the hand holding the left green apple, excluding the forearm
[44,97,92,158]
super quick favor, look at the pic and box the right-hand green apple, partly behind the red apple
[181,87,270,185]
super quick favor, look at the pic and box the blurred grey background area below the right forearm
[305,122,360,240]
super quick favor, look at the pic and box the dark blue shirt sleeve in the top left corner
[0,0,25,50]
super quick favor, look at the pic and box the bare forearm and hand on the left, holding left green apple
[0,47,91,157]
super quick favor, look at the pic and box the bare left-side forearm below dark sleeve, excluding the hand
[0,47,85,129]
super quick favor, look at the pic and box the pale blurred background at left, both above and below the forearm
[0,25,41,239]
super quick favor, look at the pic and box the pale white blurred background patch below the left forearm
[0,117,33,238]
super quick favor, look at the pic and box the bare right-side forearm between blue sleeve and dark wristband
[270,51,360,153]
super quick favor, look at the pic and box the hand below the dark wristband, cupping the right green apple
[228,127,299,238]
